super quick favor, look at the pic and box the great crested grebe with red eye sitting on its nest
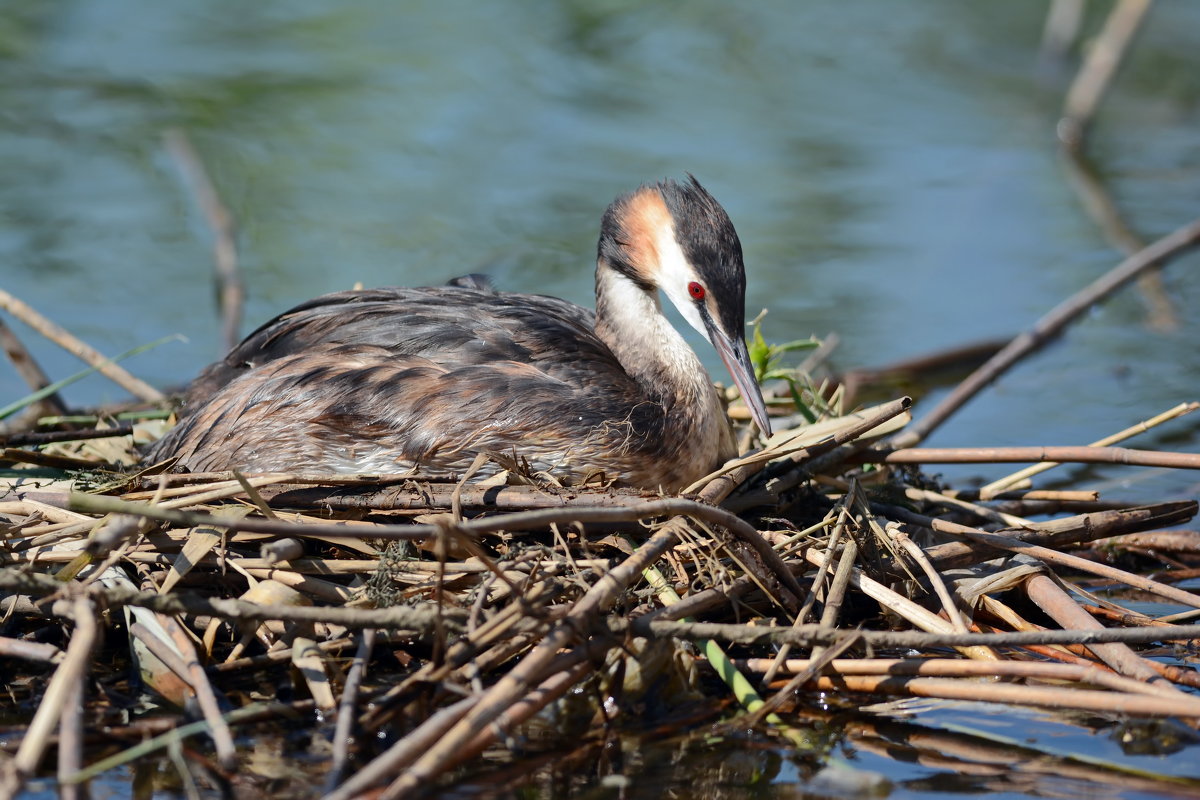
[149,176,770,491]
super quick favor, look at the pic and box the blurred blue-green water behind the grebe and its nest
[0,0,1200,796]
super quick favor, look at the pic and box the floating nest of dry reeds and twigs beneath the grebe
[0,383,1200,798]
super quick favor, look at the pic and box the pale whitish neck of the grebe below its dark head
[596,261,719,416]
